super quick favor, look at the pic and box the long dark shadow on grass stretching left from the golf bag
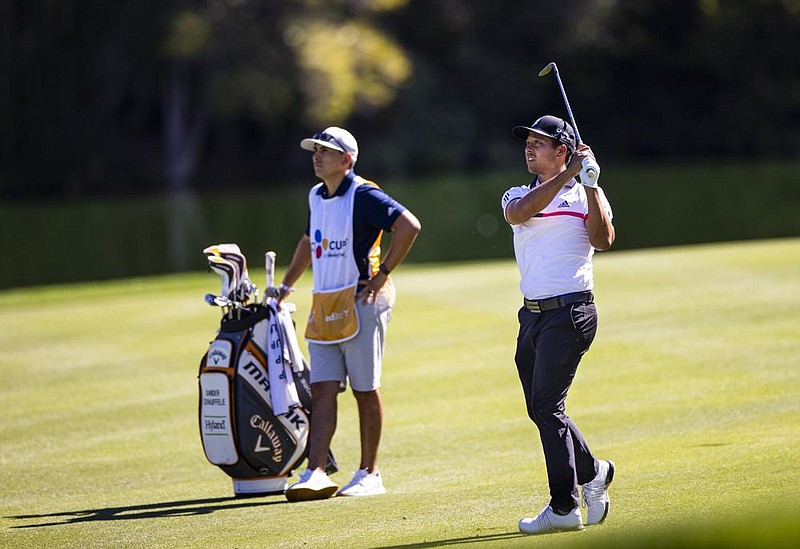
[6,496,289,528]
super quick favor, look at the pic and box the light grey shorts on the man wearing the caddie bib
[308,284,394,391]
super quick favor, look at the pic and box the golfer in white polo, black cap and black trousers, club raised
[502,116,614,534]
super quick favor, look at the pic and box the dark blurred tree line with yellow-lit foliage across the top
[0,0,800,200]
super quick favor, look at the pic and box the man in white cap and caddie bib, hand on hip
[279,127,420,501]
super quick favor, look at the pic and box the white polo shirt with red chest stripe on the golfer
[501,179,612,300]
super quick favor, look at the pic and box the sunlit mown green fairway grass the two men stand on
[0,238,800,548]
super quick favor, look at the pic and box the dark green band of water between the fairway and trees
[0,161,800,287]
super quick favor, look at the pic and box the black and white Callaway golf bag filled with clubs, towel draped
[199,244,338,497]
